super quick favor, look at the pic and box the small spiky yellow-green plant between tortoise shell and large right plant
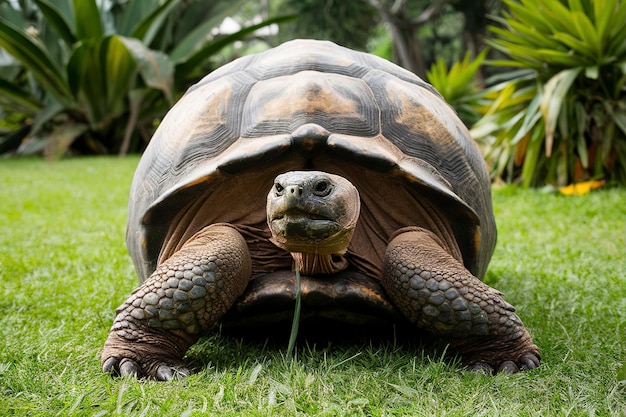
[426,49,487,126]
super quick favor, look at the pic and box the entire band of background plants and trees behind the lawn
[0,0,626,186]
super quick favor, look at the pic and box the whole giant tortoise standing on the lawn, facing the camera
[102,40,540,380]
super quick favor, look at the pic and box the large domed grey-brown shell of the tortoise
[127,40,496,281]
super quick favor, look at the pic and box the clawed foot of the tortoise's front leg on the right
[451,331,541,374]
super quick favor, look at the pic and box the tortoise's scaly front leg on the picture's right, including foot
[383,227,540,372]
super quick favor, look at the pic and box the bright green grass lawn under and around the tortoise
[0,158,626,416]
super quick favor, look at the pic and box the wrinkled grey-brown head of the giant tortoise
[267,171,360,255]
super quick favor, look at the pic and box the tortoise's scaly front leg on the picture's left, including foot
[102,224,251,380]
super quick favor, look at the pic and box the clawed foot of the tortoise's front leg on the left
[102,331,191,381]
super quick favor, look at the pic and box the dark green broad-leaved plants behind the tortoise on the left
[0,0,288,157]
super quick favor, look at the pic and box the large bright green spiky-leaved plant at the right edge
[472,0,626,186]
